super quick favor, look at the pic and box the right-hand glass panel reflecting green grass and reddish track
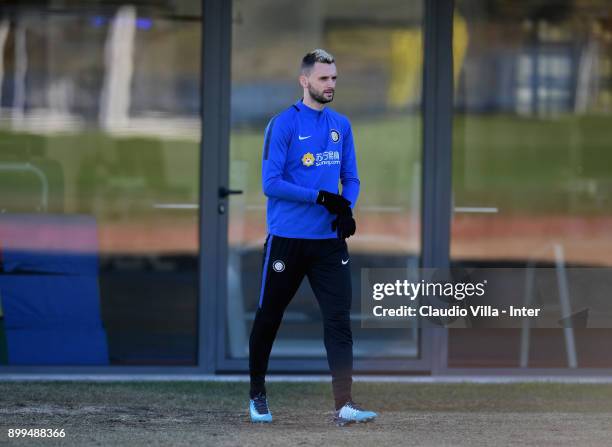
[449,0,612,366]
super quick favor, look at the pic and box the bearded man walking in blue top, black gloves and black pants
[249,49,376,424]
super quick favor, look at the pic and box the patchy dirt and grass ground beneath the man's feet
[0,382,612,446]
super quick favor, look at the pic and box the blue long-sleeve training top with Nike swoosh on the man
[262,100,359,239]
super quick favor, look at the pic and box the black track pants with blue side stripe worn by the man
[249,235,353,408]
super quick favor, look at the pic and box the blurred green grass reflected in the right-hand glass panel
[453,116,612,214]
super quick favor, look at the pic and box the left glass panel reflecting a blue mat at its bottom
[0,1,201,365]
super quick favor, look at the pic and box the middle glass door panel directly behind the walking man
[227,0,422,359]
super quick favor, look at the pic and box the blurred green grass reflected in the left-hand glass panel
[0,131,200,218]
